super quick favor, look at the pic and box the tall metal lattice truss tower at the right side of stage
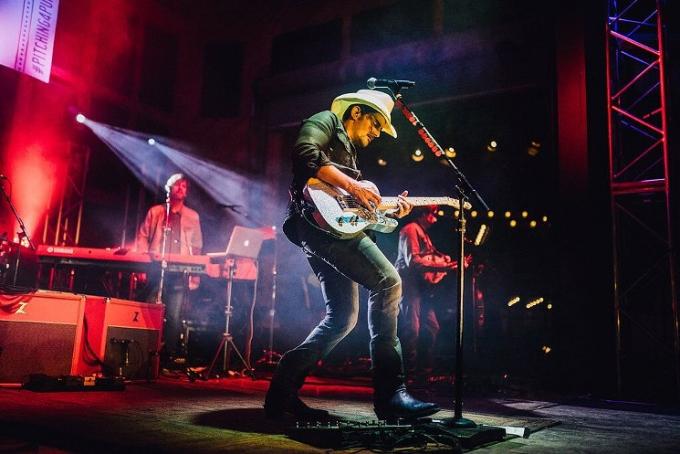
[606,0,680,399]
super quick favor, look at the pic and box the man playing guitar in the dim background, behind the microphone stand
[395,205,471,384]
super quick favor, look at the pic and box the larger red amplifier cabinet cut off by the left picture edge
[0,290,85,383]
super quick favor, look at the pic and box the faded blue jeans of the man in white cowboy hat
[271,220,404,399]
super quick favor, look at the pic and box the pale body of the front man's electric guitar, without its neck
[303,178,399,239]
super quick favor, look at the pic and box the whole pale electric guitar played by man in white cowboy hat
[303,178,471,239]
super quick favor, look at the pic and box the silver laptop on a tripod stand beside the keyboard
[203,225,264,379]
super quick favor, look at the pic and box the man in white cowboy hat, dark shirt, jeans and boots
[264,90,439,420]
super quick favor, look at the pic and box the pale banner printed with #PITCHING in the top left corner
[0,0,59,82]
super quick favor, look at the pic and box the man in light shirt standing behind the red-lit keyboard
[136,173,203,369]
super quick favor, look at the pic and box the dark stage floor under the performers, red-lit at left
[0,377,680,453]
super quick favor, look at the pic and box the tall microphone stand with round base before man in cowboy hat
[389,85,488,435]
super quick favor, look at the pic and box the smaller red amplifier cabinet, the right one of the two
[80,297,163,380]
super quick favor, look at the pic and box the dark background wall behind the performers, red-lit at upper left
[0,0,678,393]
